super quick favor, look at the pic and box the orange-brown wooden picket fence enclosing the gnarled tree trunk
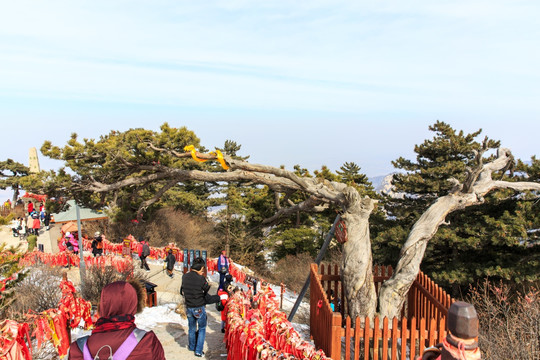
[310,264,454,360]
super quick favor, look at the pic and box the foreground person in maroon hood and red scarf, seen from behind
[68,280,165,360]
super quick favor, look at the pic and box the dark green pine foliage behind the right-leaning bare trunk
[372,122,540,295]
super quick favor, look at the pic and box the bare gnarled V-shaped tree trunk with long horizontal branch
[64,147,540,318]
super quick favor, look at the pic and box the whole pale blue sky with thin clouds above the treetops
[0,0,540,200]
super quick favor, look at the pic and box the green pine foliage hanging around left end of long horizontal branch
[38,123,220,221]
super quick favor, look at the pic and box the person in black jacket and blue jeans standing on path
[180,257,220,357]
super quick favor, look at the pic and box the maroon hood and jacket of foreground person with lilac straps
[69,283,165,360]
